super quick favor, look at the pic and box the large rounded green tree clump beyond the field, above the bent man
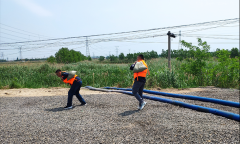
[55,48,87,63]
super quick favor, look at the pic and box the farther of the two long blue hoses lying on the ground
[104,87,240,108]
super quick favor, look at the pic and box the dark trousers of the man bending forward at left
[67,81,86,106]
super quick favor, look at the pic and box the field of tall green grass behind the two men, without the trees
[0,58,239,88]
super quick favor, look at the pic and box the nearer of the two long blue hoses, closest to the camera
[85,86,240,121]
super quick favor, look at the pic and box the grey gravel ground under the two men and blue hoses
[0,88,239,144]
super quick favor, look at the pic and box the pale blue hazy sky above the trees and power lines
[0,0,239,60]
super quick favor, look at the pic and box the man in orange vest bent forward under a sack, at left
[56,69,87,109]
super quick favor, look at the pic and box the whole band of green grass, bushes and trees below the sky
[0,39,240,88]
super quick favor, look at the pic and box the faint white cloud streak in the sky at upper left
[15,0,52,16]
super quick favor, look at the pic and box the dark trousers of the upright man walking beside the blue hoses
[132,80,145,105]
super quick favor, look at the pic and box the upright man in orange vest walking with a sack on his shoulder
[130,54,149,110]
